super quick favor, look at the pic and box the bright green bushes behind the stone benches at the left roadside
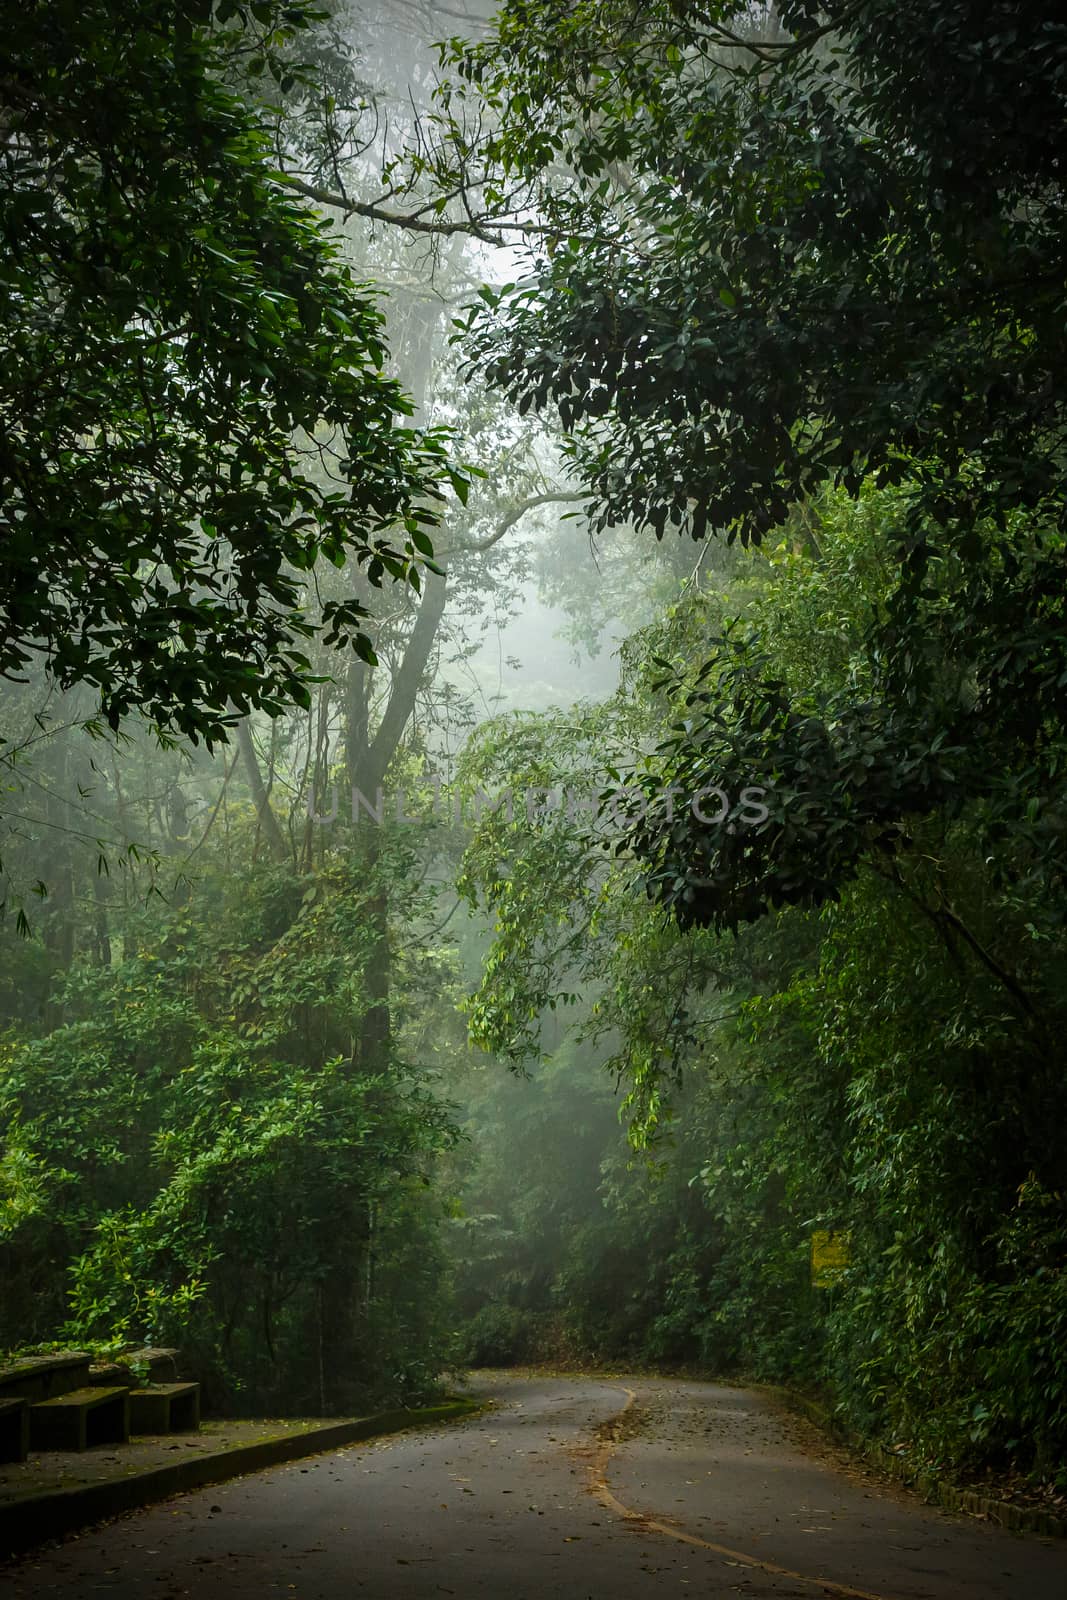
[0,808,454,1411]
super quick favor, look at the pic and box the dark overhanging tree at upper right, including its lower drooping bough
[428,0,1067,926]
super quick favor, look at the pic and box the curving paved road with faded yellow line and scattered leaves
[0,1374,1067,1600]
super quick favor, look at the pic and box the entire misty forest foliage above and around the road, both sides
[0,0,1067,1491]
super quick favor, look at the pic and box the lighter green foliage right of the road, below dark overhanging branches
[461,490,1067,1475]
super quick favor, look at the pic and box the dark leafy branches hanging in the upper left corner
[0,0,462,742]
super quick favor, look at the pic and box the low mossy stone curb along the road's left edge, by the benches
[0,1400,485,1557]
